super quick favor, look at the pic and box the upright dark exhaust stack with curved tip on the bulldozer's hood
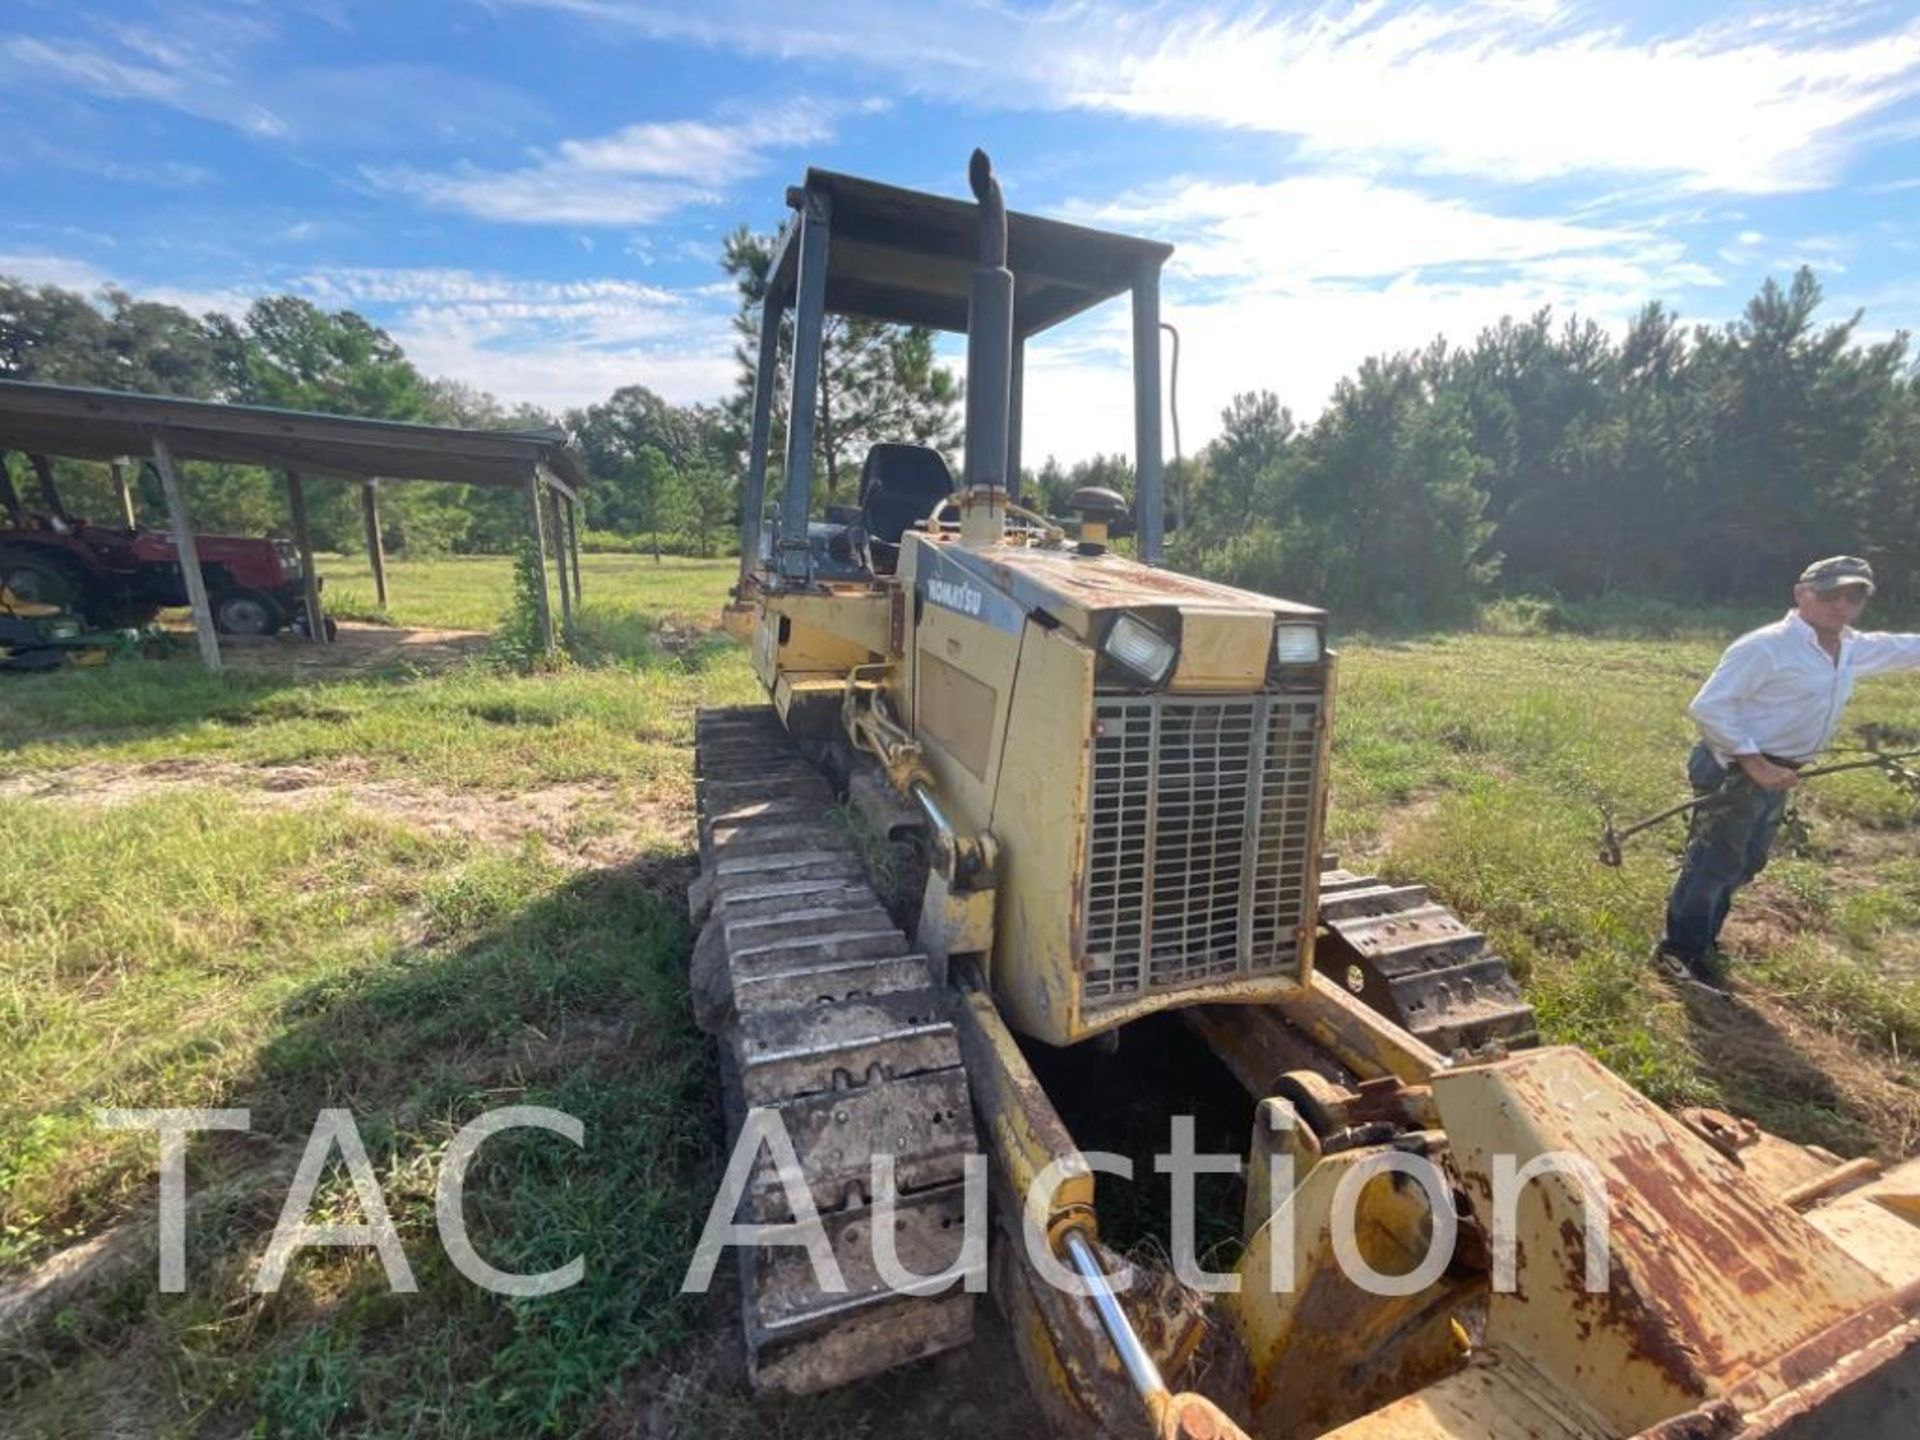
[960,150,1014,545]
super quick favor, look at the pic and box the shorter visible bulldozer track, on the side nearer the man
[1315,856,1540,1054]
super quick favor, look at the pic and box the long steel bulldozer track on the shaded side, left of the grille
[689,705,979,1394]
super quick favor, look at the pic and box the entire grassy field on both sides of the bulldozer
[0,555,1920,1436]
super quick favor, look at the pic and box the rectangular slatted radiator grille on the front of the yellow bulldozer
[1083,695,1319,1004]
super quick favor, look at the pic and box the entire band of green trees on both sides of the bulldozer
[0,263,1920,624]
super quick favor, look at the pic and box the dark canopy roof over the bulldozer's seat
[768,169,1173,336]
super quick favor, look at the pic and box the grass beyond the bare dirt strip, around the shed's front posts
[0,555,756,789]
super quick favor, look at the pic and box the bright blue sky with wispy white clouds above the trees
[0,0,1920,463]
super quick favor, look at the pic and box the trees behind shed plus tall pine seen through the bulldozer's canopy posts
[0,227,960,557]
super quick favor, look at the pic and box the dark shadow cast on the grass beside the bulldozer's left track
[0,860,720,1436]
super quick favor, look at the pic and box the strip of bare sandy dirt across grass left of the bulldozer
[0,758,693,868]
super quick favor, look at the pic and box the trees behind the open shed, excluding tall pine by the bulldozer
[0,276,737,555]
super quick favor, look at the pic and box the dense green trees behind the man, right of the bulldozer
[1167,269,1920,624]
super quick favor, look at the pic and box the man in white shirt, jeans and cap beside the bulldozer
[1653,555,1920,985]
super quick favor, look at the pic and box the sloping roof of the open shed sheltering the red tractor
[0,380,586,495]
